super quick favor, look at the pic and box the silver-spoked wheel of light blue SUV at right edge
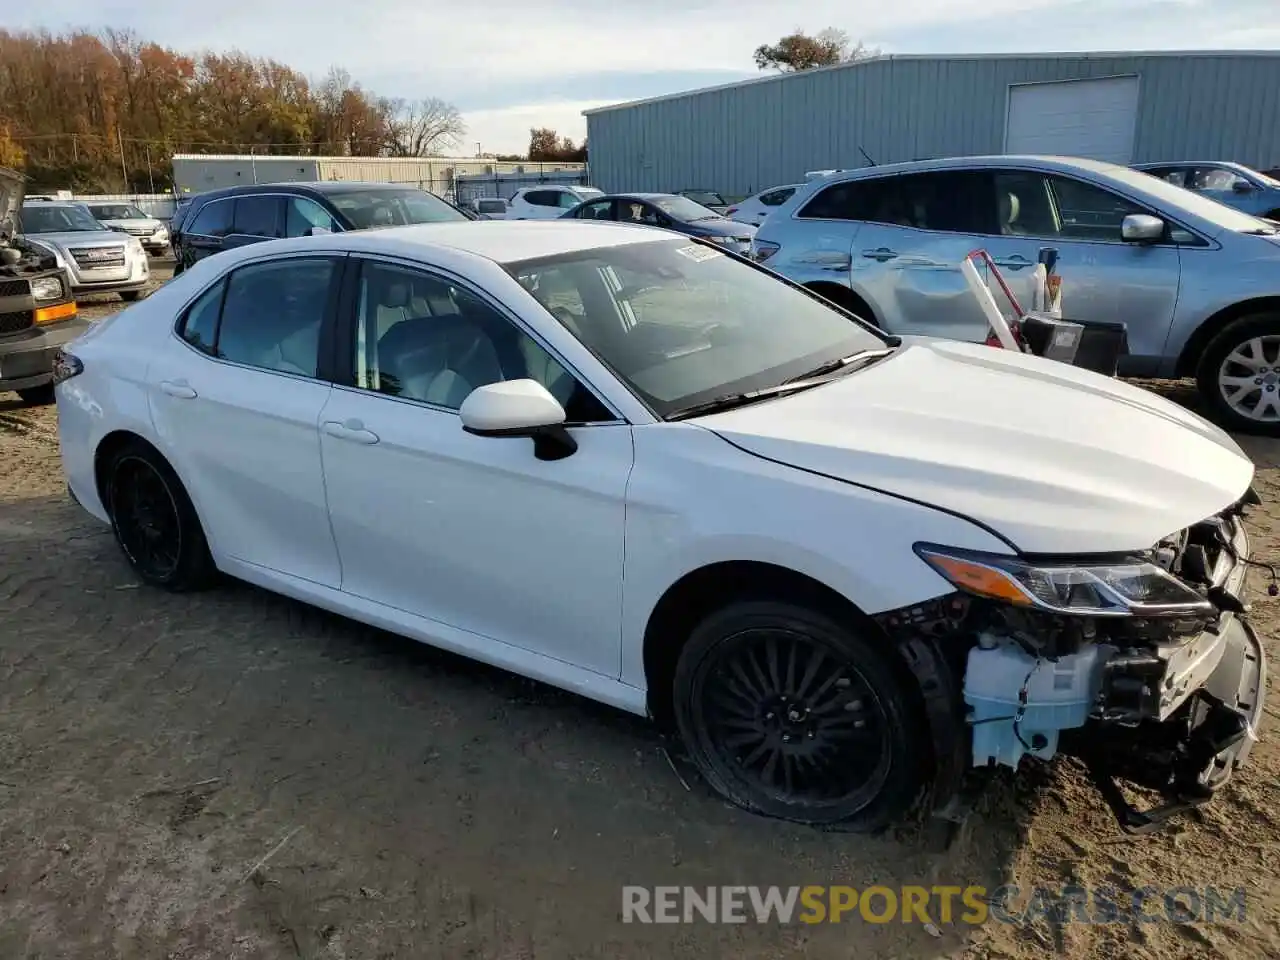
[1196,314,1280,436]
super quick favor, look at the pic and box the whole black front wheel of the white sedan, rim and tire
[673,602,929,831]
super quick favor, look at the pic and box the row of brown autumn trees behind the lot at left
[0,29,463,192]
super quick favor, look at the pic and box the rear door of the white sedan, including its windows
[146,256,340,588]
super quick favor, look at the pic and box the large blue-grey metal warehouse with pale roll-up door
[586,51,1280,195]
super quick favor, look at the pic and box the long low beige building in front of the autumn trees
[173,154,584,196]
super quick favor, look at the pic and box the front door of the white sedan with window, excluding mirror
[320,260,632,677]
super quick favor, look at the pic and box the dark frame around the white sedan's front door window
[330,252,631,429]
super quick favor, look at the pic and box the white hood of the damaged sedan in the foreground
[691,338,1253,554]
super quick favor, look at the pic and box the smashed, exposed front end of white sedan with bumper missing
[878,490,1266,832]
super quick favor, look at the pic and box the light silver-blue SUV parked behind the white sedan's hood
[753,156,1280,436]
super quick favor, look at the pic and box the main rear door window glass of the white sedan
[216,257,335,376]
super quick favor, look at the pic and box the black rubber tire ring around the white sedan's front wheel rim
[672,600,929,832]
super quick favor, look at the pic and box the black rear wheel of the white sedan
[104,443,214,593]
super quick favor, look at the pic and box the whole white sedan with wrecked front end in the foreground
[56,221,1265,829]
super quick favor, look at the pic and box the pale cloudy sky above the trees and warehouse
[12,0,1280,152]
